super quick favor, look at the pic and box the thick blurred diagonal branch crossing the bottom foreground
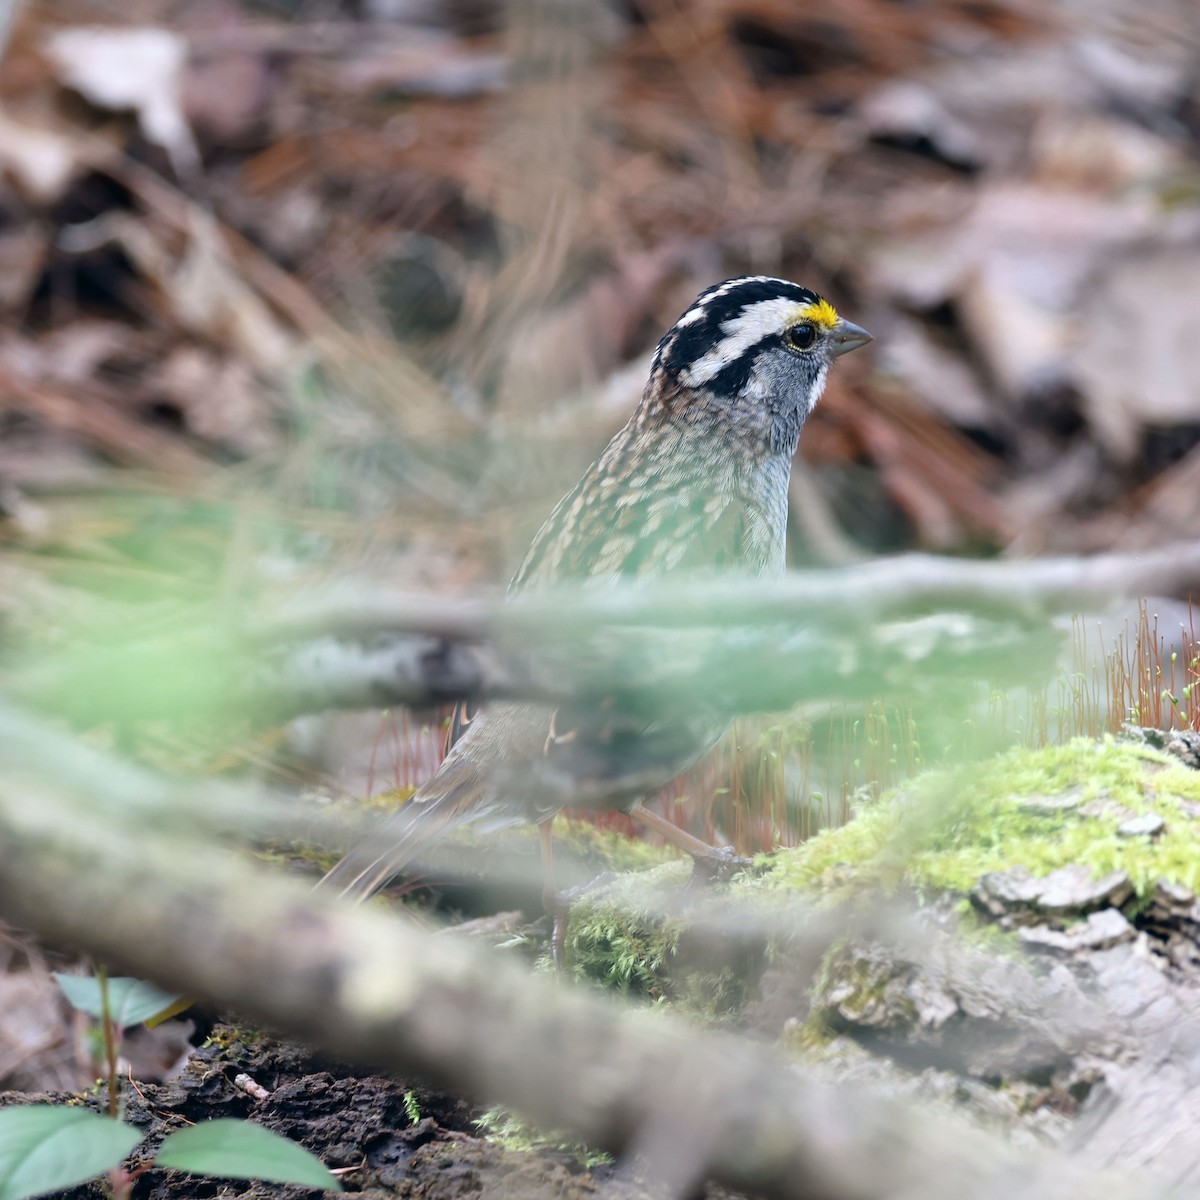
[0,763,1152,1200]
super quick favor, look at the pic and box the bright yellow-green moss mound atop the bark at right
[758,739,1200,899]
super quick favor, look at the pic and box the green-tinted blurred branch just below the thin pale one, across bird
[7,613,1063,724]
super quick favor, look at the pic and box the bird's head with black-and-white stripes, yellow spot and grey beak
[643,275,871,456]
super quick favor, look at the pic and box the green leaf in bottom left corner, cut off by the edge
[0,1104,142,1200]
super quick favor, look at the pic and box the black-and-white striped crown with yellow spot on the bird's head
[654,275,838,388]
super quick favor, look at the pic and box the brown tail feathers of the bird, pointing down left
[318,761,480,901]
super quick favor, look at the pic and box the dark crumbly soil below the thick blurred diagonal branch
[21,1026,676,1200]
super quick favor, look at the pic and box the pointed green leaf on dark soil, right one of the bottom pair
[157,1118,342,1200]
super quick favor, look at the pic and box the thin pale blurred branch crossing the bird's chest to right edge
[267,541,1200,641]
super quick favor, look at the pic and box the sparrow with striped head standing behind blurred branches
[320,275,871,945]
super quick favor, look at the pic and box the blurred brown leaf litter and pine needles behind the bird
[0,0,1200,864]
